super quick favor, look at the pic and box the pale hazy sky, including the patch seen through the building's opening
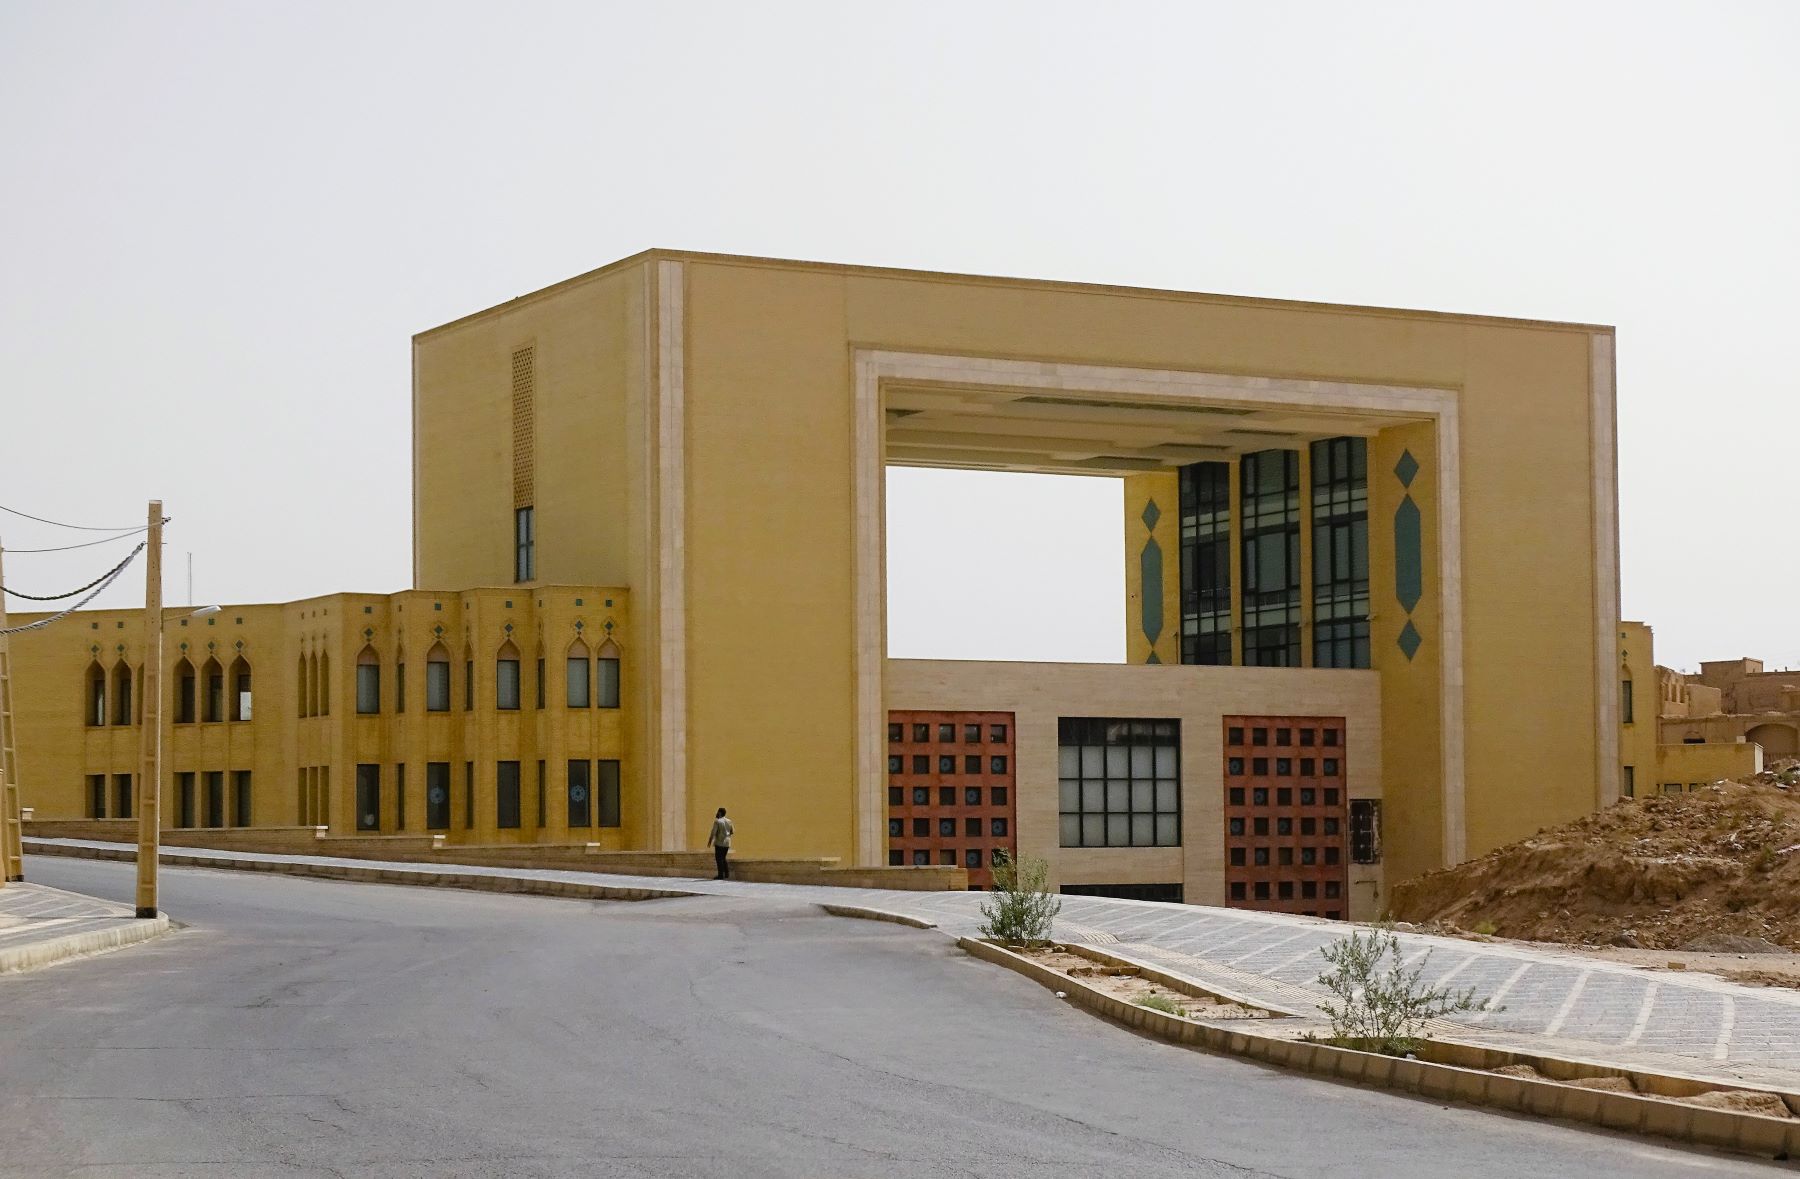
[0,0,1800,668]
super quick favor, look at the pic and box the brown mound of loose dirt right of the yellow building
[1391,774,1800,950]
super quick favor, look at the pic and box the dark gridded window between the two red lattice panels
[1057,716,1181,848]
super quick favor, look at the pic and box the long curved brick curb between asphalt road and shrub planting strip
[956,938,1800,1159]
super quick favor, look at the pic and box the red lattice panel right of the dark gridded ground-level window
[1224,716,1350,918]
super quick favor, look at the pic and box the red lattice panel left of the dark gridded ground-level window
[887,711,1019,889]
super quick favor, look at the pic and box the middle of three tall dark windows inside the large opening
[1238,450,1300,668]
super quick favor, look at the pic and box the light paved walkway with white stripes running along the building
[27,841,1800,1089]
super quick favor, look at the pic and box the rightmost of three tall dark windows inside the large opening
[1312,437,1370,668]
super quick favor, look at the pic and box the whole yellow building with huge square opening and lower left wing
[16,250,1627,916]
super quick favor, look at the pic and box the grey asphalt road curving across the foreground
[0,857,1771,1179]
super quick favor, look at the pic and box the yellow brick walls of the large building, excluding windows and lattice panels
[16,250,1627,911]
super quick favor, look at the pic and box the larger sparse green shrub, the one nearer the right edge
[1319,925,1505,1057]
